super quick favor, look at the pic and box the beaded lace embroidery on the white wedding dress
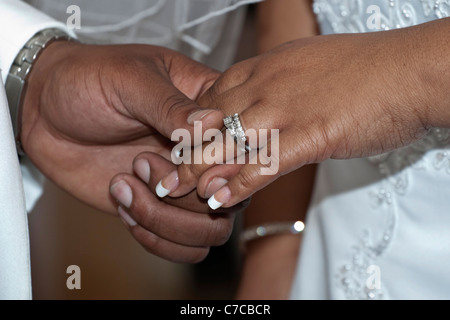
[313,0,450,299]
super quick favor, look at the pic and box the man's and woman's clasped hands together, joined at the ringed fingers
[21,21,446,262]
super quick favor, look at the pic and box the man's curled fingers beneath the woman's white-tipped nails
[111,152,249,263]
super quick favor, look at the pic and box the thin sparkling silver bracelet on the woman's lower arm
[239,221,305,247]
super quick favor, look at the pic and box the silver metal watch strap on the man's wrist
[5,28,71,155]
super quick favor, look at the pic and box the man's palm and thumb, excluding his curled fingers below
[21,41,223,213]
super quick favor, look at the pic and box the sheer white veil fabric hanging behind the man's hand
[27,0,261,70]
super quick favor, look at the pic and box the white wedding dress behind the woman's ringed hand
[291,0,450,299]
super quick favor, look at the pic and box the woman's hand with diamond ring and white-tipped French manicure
[153,22,450,208]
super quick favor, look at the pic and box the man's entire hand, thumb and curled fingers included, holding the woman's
[21,41,246,262]
